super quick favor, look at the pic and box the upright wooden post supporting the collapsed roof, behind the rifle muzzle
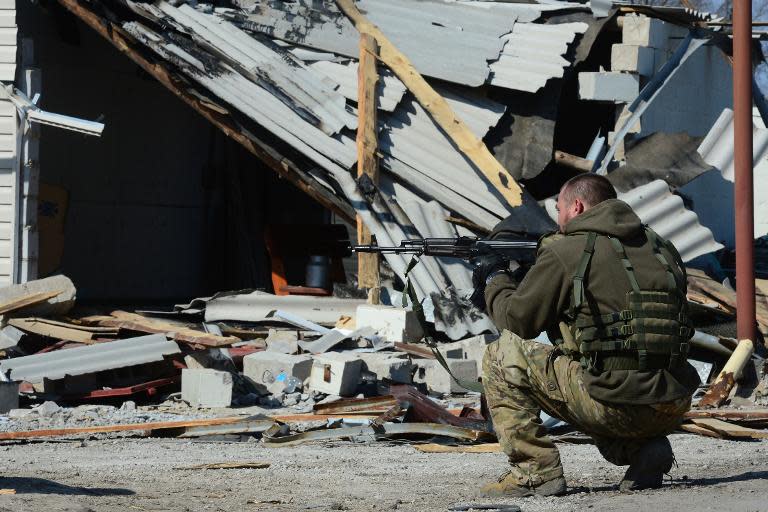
[357,34,381,296]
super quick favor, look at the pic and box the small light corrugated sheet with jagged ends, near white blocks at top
[488,23,589,92]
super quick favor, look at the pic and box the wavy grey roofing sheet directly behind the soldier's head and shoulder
[619,180,723,261]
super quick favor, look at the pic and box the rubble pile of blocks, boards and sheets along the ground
[0,270,768,446]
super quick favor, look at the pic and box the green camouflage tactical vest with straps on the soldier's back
[569,227,693,371]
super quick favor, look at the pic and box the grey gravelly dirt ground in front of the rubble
[0,434,768,512]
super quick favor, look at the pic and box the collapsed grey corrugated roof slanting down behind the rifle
[51,0,728,338]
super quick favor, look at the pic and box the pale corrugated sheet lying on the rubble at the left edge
[0,334,181,383]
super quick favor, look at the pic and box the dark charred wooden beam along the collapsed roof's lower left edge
[59,0,355,223]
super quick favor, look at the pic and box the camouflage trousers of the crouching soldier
[483,331,691,486]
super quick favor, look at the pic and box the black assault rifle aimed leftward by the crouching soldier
[350,236,538,261]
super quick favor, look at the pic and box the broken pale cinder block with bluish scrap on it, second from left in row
[243,351,312,394]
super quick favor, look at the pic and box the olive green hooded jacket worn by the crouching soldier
[485,199,699,404]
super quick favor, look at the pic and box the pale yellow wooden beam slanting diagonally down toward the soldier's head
[340,0,522,206]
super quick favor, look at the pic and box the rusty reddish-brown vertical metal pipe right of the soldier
[733,0,755,340]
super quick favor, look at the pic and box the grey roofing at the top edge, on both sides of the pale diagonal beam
[231,0,515,87]
